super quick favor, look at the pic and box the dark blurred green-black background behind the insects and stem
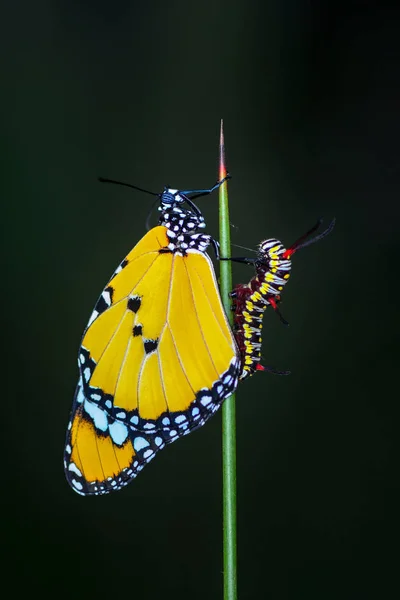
[0,0,400,600]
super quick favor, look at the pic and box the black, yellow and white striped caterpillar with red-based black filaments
[227,219,335,379]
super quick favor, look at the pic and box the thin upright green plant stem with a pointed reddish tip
[219,121,237,600]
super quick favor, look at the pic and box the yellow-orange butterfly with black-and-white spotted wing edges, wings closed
[64,177,241,495]
